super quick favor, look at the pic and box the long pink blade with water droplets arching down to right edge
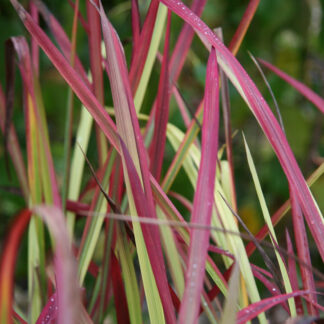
[161,0,324,260]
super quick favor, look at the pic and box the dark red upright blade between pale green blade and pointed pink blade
[149,10,171,181]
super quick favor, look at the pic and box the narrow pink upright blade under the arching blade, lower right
[290,191,318,315]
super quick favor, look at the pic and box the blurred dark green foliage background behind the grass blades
[0,0,324,262]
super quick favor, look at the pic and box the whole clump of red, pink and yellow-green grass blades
[0,0,324,324]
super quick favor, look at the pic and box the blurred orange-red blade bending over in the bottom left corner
[0,209,31,324]
